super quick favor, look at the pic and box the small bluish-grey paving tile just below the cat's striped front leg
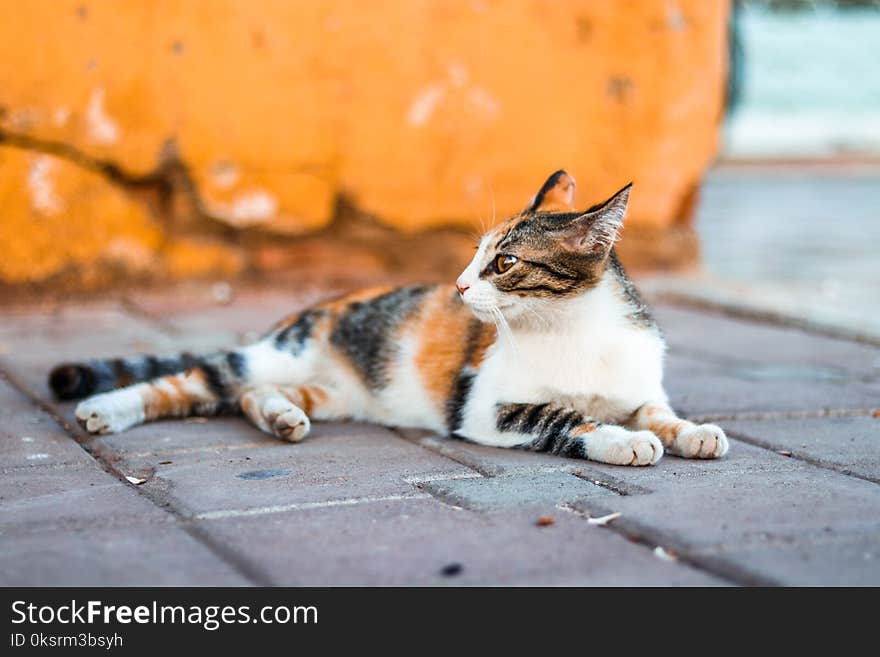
[419,472,615,510]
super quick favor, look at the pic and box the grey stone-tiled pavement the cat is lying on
[0,286,880,586]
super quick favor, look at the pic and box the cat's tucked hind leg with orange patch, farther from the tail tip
[239,384,344,443]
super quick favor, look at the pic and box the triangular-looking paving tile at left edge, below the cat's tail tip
[0,379,92,468]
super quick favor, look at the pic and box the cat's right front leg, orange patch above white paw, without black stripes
[633,403,729,459]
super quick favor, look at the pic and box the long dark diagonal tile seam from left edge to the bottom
[0,359,273,586]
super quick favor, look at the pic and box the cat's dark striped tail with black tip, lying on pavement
[49,351,239,399]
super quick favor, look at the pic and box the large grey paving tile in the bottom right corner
[575,466,880,584]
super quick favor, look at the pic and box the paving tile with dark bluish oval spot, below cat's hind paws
[124,423,474,515]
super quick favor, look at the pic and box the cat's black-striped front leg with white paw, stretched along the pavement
[468,403,663,465]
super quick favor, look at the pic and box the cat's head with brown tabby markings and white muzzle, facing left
[456,171,632,321]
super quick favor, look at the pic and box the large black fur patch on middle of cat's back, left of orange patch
[330,286,431,390]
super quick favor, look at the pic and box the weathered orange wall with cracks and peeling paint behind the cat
[0,0,728,285]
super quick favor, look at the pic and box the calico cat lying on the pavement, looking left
[49,170,728,465]
